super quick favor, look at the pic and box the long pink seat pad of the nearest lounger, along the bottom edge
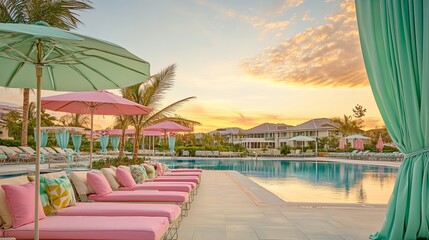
[3,216,169,240]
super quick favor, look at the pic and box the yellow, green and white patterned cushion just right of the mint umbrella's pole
[43,176,76,213]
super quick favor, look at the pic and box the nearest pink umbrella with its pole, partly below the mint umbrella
[42,91,152,169]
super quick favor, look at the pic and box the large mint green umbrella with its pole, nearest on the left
[0,22,149,239]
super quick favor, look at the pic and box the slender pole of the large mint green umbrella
[34,62,42,240]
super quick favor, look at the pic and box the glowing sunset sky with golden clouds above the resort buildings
[0,0,384,132]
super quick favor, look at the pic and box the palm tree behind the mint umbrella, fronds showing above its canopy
[0,0,92,146]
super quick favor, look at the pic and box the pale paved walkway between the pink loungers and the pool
[179,171,385,240]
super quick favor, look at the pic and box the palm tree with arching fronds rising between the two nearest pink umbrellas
[122,64,200,159]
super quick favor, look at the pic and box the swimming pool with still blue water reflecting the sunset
[160,159,398,204]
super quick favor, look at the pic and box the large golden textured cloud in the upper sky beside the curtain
[241,0,368,87]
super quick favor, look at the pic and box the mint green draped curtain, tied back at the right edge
[356,0,429,239]
